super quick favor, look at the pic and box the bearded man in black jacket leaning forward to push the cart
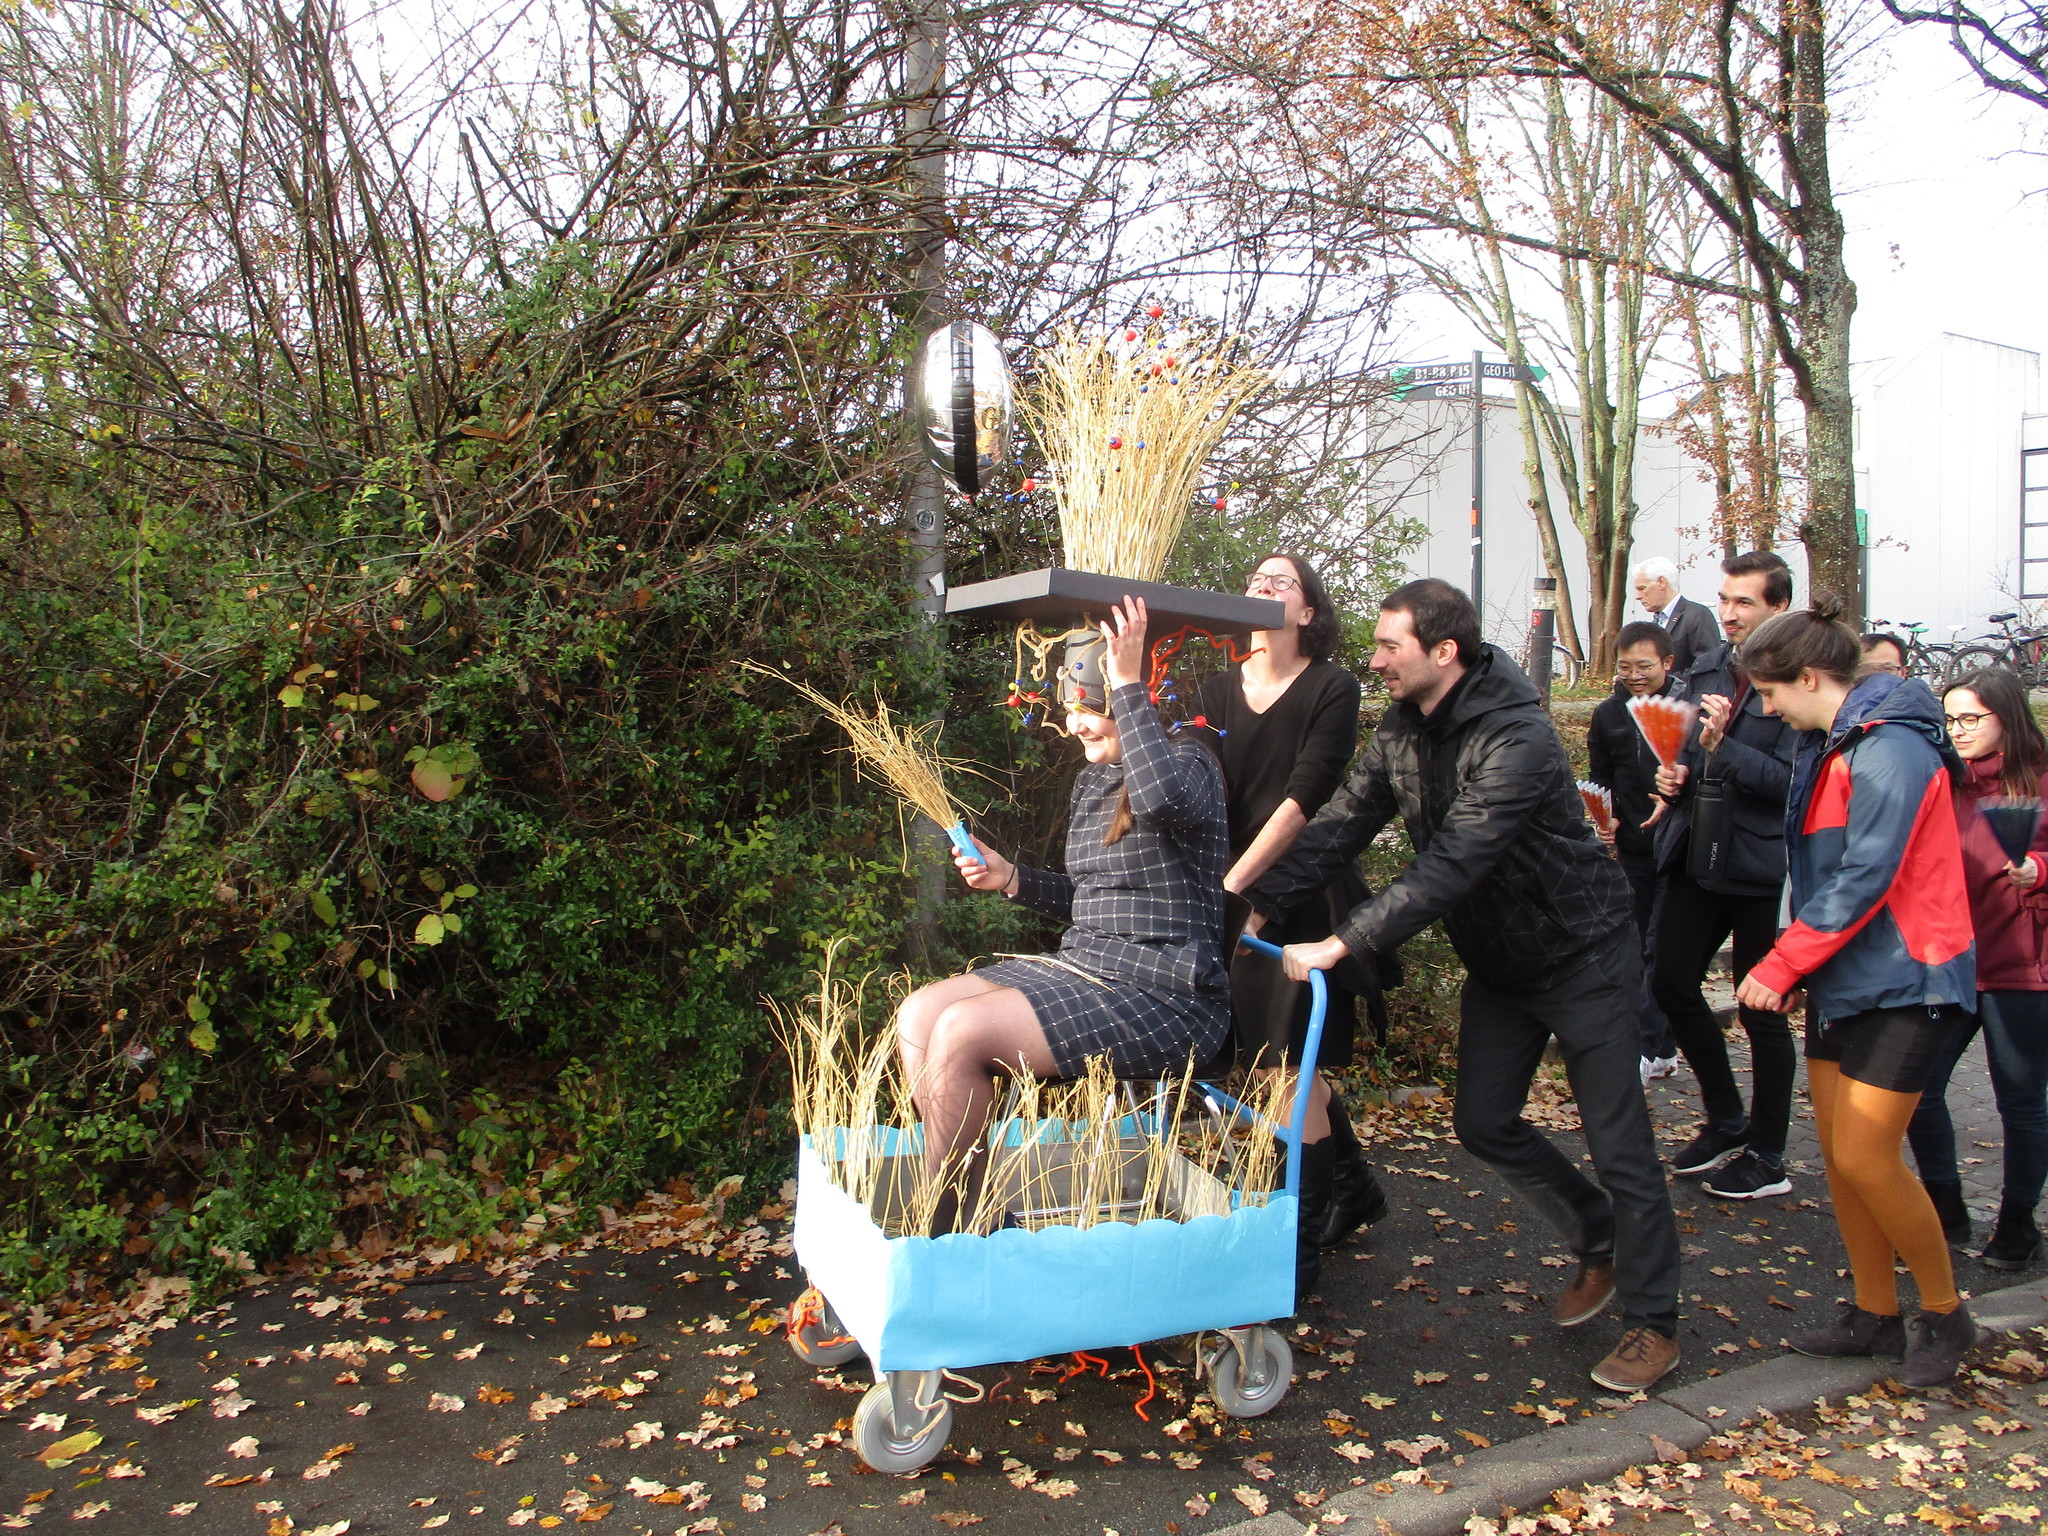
[1247,580,1679,1393]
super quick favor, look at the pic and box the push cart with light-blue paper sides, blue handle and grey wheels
[788,938,1327,1473]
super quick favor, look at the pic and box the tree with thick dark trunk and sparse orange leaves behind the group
[1212,0,1862,606]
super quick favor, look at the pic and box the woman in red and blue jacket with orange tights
[1737,594,1976,1386]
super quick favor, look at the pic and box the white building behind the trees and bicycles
[1399,334,2048,649]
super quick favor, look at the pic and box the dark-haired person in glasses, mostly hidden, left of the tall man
[1585,621,1686,1083]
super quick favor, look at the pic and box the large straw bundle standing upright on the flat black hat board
[1024,328,1270,582]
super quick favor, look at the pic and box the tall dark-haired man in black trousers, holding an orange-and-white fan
[1651,551,1798,1200]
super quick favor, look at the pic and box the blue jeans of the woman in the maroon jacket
[1907,991,2048,1212]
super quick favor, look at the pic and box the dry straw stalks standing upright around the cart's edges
[770,962,1286,1235]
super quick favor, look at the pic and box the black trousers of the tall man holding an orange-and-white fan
[1651,870,1798,1157]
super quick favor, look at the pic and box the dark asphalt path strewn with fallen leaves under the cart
[0,1040,2031,1536]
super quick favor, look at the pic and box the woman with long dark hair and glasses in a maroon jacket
[1907,668,2048,1270]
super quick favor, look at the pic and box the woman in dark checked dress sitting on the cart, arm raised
[897,598,1231,1235]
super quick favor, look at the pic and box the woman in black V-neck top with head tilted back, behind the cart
[1194,555,1386,1296]
